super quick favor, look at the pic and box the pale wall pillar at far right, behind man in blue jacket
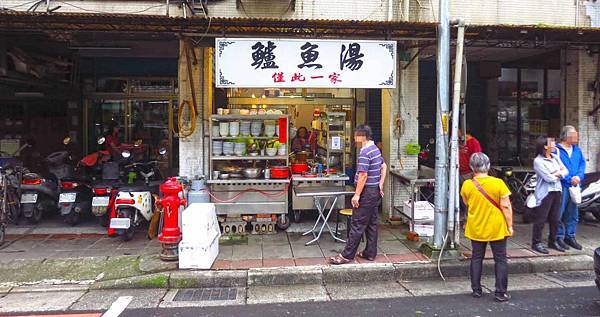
[563,49,600,172]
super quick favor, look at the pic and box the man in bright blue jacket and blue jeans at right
[556,125,585,250]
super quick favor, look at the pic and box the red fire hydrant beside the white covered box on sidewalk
[156,177,187,261]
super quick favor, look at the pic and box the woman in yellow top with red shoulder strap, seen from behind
[460,153,513,302]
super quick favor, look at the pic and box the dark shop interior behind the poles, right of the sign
[419,47,565,166]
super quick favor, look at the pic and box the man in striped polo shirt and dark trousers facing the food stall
[329,125,387,264]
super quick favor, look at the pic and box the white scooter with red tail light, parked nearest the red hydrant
[110,149,166,241]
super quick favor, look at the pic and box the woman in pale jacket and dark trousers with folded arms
[531,136,568,254]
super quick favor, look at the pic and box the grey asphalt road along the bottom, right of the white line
[121,287,600,317]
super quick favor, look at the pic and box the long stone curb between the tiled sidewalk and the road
[90,255,593,289]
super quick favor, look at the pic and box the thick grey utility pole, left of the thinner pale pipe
[433,0,450,250]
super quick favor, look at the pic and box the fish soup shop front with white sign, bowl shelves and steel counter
[195,38,396,234]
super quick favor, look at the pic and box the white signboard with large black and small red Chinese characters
[215,38,396,88]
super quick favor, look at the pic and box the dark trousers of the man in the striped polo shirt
[342,186,381,260]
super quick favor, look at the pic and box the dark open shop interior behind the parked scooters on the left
[0,32,179,231]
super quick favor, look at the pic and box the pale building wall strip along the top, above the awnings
[0,0,597,26]
